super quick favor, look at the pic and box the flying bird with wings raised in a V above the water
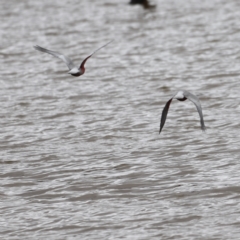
[34,40,113,77]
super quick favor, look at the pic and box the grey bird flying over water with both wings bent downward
[159,91,206,134]
